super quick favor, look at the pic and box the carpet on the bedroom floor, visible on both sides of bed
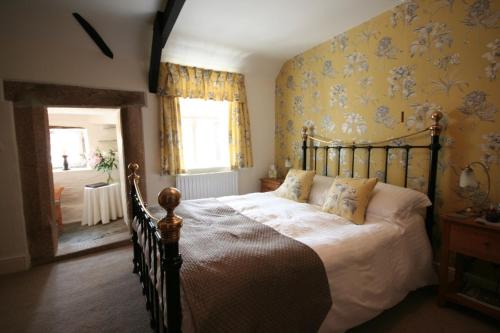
[0,246,500,333]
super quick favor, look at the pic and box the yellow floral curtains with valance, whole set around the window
[158,63,253,174]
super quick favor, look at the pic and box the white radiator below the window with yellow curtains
[175,171,238,200]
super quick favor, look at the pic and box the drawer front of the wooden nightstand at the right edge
[450,224,500,263]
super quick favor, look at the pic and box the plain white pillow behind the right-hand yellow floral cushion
[366,183,432,222]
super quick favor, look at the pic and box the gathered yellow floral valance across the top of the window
[158,63,246,103]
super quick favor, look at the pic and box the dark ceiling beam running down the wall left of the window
[149,0,185,93]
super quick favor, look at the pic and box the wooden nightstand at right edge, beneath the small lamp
[439,214,500,319]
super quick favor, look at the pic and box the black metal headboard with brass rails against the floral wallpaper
[302,112,443,240]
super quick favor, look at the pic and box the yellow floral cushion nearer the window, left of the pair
[275,169,316,202]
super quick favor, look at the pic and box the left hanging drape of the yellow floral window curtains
[160,96,185,175]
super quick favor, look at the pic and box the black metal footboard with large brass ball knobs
[128,163,182,333]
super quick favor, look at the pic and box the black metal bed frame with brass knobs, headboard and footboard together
[128,113,442,333]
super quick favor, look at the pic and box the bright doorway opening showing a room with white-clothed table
[47,107,129,256]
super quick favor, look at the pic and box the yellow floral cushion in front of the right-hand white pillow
[323,177,377,224]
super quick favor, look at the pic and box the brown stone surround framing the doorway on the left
[4,81,146,265]
